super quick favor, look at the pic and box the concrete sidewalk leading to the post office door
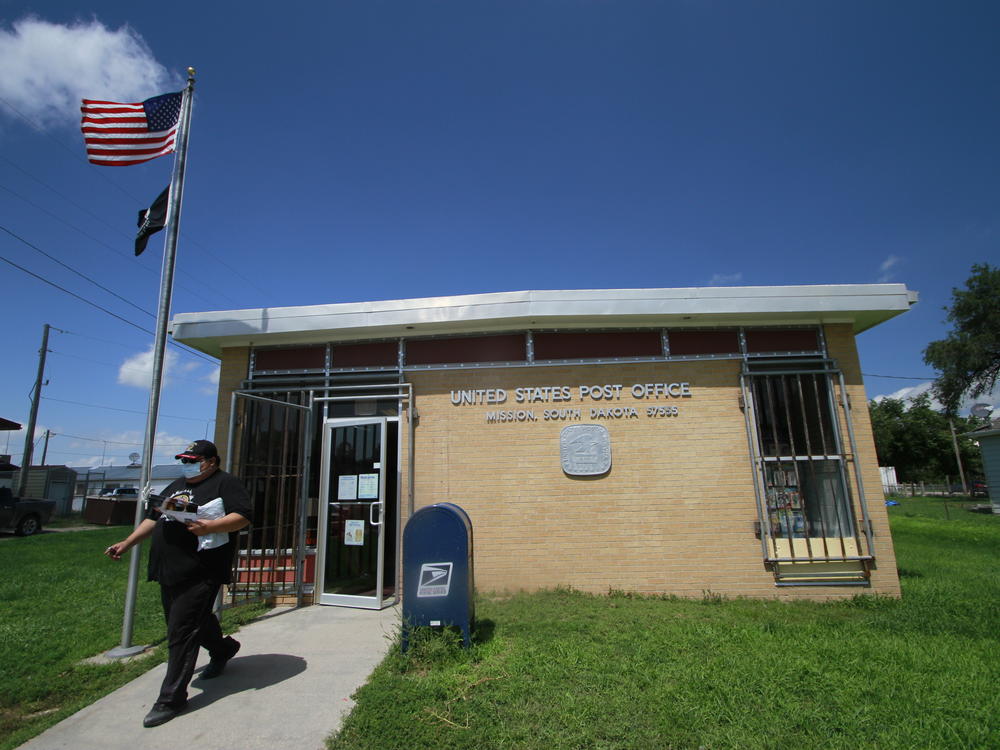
[21,606,399,750]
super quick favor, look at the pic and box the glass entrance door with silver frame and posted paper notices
[317,417,398,609]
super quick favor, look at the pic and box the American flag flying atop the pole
[80,91,183,167]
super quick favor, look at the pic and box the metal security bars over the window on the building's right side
[741,360,873,585]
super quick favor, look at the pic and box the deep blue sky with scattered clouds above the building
[0,0,1000,465]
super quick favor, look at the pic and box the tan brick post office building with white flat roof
[172,284,916,608]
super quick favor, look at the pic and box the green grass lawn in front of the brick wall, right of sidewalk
[329,498,1000,750]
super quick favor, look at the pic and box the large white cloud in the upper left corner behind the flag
[0,16,176,127]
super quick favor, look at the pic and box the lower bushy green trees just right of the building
[868,393,983,482]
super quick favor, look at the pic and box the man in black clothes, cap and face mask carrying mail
[104,440,253,727]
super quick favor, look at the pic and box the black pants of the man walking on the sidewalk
[156,581,223,707]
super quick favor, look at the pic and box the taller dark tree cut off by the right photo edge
[924,263,1000,414]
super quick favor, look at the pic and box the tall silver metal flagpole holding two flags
[106,68,194,658]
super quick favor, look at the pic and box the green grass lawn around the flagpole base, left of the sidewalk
[0,527,261,750]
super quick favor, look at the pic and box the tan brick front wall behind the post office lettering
[403,356,898,598]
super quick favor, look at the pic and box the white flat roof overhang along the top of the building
[171,284,917,357]
